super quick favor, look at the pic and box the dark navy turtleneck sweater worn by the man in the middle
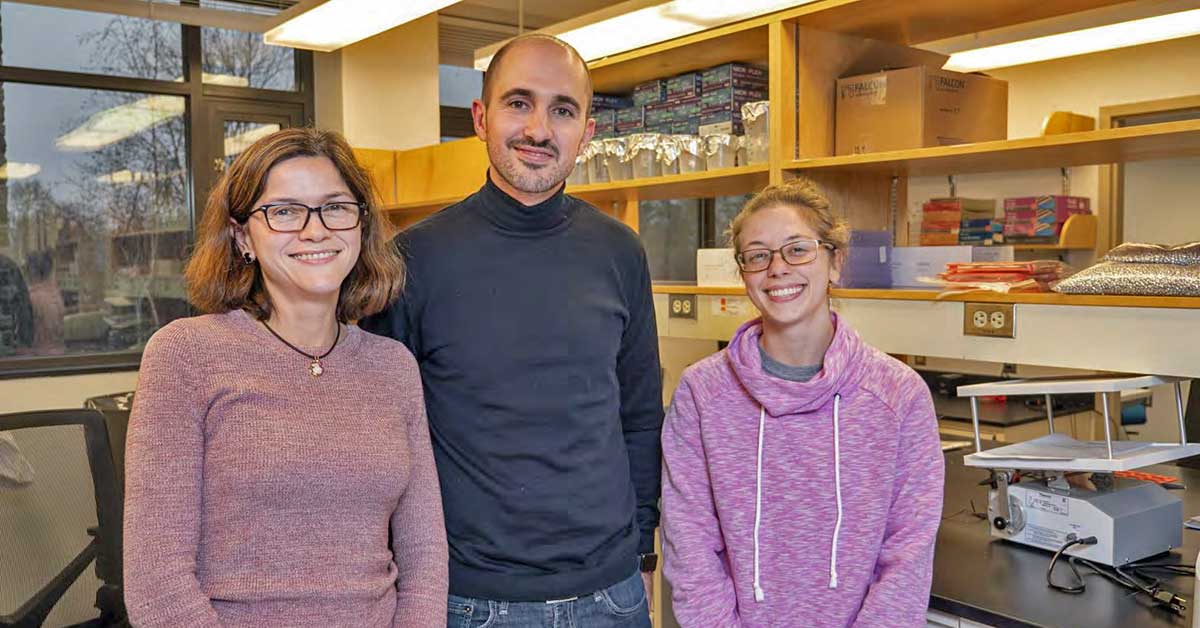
[361,174,662,602]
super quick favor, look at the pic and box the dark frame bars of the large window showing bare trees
[0,9,316,379]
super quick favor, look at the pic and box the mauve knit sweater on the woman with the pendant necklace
[125,310,448,627]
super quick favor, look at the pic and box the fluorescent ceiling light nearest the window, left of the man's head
[263,0,457,53]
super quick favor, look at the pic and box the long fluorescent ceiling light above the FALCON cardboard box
[946,8,1200,72]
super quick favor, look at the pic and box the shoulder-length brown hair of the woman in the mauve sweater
[184,127,404,323]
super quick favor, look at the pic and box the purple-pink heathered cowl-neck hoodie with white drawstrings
[662,316,944,628]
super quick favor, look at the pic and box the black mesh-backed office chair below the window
[0,409,128,628]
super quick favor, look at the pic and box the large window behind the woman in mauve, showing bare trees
[0,0,312,377]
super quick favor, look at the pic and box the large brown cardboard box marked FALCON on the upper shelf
[834,66,1008,155]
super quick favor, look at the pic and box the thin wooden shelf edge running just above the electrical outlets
[653,283,1200,310]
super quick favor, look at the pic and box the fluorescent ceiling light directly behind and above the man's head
[475,0,815,71]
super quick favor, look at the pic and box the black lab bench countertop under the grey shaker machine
[930,448,1200,628]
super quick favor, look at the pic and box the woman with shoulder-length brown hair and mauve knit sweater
[125,128,448,628]
